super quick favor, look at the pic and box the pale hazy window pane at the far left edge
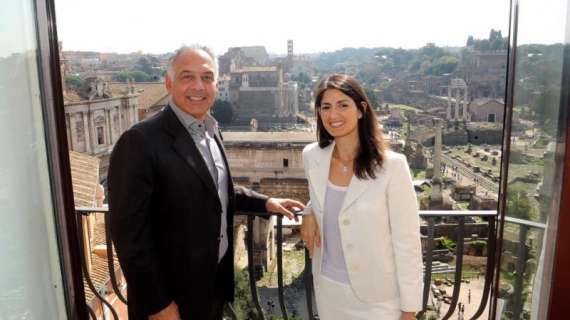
[0,0,66,319]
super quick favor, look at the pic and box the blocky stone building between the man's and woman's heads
[229,66,299,126]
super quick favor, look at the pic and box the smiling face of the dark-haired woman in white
[319,89,362,138]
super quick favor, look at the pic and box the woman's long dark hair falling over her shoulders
[315,74,386,179]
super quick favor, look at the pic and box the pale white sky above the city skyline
[0,0,566,57]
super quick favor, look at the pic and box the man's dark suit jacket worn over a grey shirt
[108,107,267,320]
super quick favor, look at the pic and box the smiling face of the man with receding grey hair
[166,49,218,120]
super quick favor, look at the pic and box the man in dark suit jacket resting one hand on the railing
[108,47,303,320]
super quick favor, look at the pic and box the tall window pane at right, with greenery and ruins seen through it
[498,0,567,319]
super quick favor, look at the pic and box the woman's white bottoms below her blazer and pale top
[315,275,402,320]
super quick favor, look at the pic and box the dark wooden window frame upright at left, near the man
[34,0,89,319]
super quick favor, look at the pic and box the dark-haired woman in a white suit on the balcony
[301,75,423,320]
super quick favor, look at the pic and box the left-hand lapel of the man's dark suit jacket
[163,106,218,194]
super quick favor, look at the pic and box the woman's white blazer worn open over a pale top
[303,142,423,311]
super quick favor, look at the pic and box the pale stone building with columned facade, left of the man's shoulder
[64,78,139,180]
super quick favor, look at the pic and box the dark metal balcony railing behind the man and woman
[76,207,546,320]
